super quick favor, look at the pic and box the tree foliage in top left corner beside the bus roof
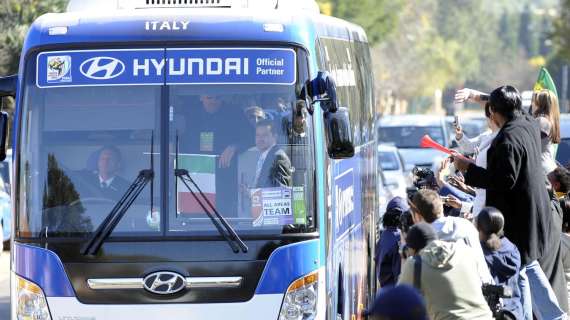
[0,0,67,75]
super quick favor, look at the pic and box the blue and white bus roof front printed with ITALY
[23,8,367,53]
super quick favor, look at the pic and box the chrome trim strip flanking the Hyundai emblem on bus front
[87,277,243,290]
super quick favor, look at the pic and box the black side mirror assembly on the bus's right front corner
[310,72,354,159]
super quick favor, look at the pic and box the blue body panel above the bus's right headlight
[255,239,319,294]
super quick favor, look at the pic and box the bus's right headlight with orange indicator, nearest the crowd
[279,272,319,320]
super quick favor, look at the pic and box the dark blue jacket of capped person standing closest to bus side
[374,227,402,288]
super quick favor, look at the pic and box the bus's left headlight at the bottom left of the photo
[16,276,51,320]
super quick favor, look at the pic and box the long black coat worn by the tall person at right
[465,115,552,265]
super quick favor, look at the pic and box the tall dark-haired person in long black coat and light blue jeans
[453,86,565,319]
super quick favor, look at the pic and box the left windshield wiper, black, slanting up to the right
[81,169,154,255]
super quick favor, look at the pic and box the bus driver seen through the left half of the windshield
[91,146,130,200]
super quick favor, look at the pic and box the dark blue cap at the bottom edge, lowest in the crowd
[364,284,428,320]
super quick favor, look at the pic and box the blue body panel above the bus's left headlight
[14,243,75,297]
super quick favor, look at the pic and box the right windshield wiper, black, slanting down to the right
[174,134,248,253]
